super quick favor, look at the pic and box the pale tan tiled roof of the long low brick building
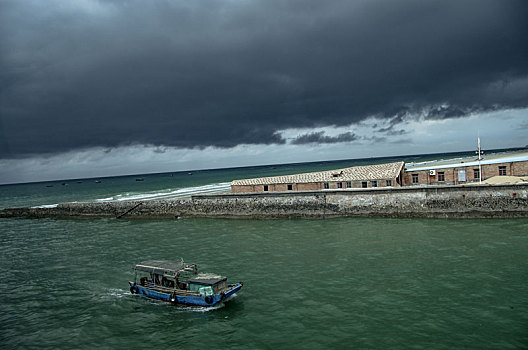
[231,162,403,186]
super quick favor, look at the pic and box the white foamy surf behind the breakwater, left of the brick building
[96,182,231,202]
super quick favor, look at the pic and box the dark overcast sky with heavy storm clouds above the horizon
[0,0,528,183]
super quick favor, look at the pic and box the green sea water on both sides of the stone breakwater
[0,152,528,349]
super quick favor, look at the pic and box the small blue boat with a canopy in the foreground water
[128,260,243,306]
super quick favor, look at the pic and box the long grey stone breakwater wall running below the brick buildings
[0,183,528,219]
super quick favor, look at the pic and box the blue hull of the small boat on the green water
[128,282,242,307]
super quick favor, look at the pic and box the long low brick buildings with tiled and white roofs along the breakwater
[231,152,528,193]
